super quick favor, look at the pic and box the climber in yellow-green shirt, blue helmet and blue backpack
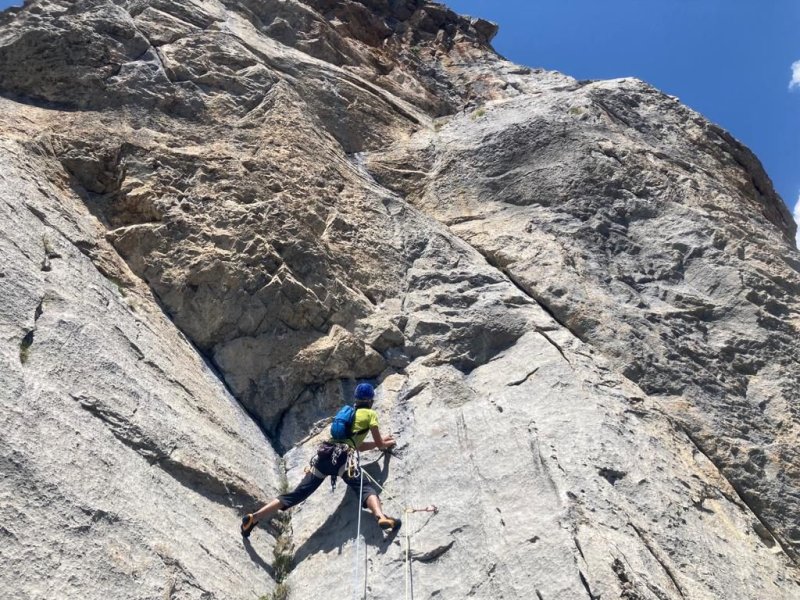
[236,383,401,537]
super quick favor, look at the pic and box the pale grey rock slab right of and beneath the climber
[287,333,798,599]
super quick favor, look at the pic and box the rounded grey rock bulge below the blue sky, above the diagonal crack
[369,80,800,552]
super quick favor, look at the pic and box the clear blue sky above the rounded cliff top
[0,0,800,241]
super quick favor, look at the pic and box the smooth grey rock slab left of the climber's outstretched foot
[0,125,282,598]
